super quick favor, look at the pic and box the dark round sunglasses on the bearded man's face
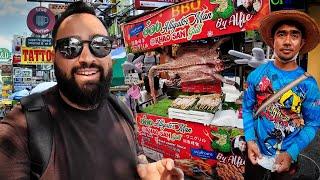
[55,35,112,59]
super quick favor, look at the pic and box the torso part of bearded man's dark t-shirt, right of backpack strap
[46,89,136,180]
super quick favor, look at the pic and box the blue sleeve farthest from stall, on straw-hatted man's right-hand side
[287,79,320,161]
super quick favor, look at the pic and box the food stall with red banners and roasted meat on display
[122,0,270,179]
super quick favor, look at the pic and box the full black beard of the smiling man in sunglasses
[54,64,112,108]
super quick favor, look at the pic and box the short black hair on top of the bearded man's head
[52,1,107,44]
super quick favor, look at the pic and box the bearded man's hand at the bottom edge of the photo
[137,159,184,180]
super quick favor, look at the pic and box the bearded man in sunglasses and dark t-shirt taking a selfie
[0,1,183,180]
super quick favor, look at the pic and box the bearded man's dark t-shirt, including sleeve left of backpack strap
[0,86,138,180]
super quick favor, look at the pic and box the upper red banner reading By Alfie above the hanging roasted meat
[123,0,270,52]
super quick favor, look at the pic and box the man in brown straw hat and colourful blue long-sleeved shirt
[243,10,320,179]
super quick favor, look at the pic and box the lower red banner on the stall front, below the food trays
[137,113,246,179]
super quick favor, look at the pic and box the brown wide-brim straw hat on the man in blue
[260,10,320,54]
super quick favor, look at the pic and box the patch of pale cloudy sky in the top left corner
[0,0,48,51]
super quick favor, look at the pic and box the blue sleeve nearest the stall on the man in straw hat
[242,73,256,141]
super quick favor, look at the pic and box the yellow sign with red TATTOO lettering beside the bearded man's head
[20,47,53,64]
